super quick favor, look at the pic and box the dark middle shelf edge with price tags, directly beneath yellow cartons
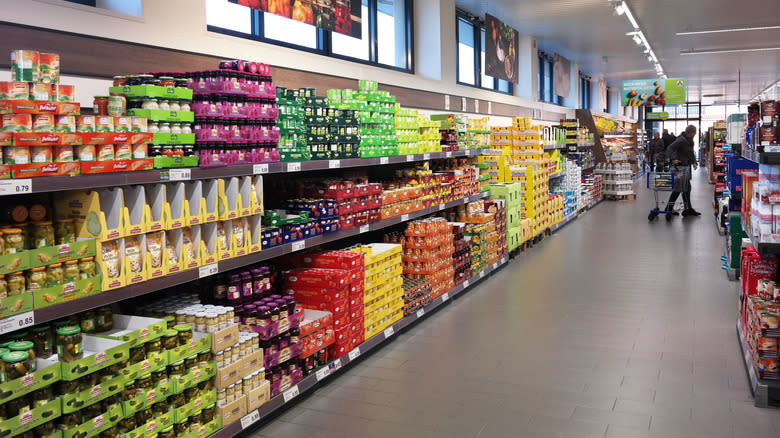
[24,192,489,325]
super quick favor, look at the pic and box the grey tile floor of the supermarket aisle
[254,171,780,438]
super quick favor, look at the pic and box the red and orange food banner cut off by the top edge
[228,0,362,38]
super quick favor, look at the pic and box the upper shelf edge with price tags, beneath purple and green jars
[0,149,481,196]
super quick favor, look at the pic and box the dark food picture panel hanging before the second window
[485,14,520,84]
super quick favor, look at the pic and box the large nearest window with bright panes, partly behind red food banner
[206,0,413,72]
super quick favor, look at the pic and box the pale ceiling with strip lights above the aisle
[456,0,780,104]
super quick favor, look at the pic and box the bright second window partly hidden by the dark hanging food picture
[456,13,512,94]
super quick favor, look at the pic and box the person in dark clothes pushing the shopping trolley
[665,125,701,222]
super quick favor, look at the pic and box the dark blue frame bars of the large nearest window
[206,0,415,74]
